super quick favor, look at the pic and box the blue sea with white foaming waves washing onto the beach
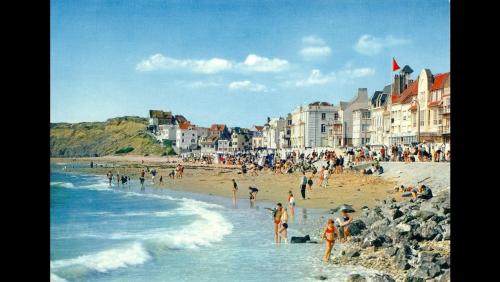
[50,166,380,281]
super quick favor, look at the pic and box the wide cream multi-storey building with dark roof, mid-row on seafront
[290,102,338,149]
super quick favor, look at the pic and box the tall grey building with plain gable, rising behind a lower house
[340,88,370,146]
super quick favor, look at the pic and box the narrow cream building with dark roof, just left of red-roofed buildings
[369,84,391,146]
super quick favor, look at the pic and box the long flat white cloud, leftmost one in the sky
[136,54,233,74]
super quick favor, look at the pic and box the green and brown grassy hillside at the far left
[50,117,165,157]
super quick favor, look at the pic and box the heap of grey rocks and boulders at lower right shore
[332,189,450,281]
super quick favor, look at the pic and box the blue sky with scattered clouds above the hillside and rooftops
[51,0,450,127]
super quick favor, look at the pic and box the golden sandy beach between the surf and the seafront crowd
[51,156,403,214]
